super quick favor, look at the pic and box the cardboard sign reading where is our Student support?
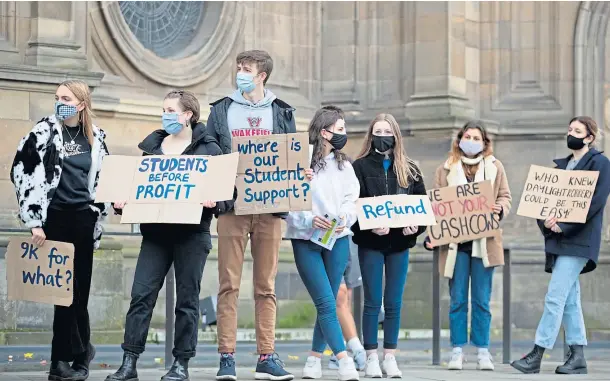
[233,133,311,215]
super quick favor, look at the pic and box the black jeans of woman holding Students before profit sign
[121,233,209,358]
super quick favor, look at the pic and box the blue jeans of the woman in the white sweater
[292,237,350,354]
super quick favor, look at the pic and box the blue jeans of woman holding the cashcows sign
[449,251,494,348]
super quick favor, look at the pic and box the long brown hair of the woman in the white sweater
[308,106,348,171]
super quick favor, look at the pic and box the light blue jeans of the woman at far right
[536,255,588,349]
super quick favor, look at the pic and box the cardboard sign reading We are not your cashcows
[428,180,500,247]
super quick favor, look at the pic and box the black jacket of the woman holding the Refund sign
[352,151,426,254]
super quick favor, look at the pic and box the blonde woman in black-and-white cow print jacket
[11,80,110,380]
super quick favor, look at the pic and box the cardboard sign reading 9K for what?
[6,237,74,306]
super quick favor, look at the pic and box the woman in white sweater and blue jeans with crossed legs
[286,106,360,381]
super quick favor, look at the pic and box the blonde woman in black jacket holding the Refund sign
[353,114,426,378]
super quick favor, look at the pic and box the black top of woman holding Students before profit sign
[129,123,233,250]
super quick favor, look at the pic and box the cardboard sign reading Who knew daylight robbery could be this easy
[517,165,599,223]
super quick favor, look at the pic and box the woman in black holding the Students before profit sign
[106,90,233,381]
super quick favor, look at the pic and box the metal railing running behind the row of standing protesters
[0,226,568,369]
